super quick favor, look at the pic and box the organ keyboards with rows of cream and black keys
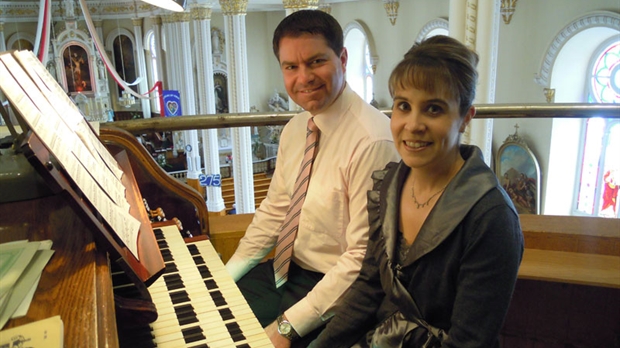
[119,225,272,348]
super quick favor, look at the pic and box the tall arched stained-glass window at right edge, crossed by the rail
[535,11,620,217]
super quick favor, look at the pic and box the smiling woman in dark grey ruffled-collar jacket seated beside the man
[311,36,523,348]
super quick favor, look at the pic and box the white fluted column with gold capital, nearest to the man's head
[220,0,255,214]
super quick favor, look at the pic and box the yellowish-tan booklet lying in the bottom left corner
[0,315,64,348]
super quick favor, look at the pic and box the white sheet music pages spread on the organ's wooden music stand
[0,51,140,259]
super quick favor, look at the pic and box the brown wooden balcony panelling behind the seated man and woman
[209,214,620,348]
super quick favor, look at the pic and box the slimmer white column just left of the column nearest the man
[191,5,226,212]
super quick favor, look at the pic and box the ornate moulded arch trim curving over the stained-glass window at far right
[534,11,620,87]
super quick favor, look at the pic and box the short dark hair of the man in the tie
[273,10,344,60]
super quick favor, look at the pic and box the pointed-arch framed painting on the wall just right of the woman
[495,126,540,214]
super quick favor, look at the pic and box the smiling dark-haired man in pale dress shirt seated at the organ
[226,10,399,347]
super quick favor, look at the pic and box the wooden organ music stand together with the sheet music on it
[0,51,164,294]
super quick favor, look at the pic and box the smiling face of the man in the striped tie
[279,34,347,115]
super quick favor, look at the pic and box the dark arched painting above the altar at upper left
[62,45,93,93]
